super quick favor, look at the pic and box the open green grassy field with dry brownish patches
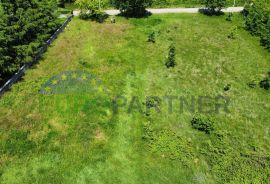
[0,14,270,184]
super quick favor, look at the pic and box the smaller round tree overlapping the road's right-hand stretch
[202,0,226,15]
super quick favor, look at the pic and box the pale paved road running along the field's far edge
[73,7,244,16]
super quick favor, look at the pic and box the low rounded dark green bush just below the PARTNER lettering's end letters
[191,116,214,134]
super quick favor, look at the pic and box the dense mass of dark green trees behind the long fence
[0,0,59,83]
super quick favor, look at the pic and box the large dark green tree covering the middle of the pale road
[109,0,153,17]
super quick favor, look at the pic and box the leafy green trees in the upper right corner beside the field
[243,1,270,51]
